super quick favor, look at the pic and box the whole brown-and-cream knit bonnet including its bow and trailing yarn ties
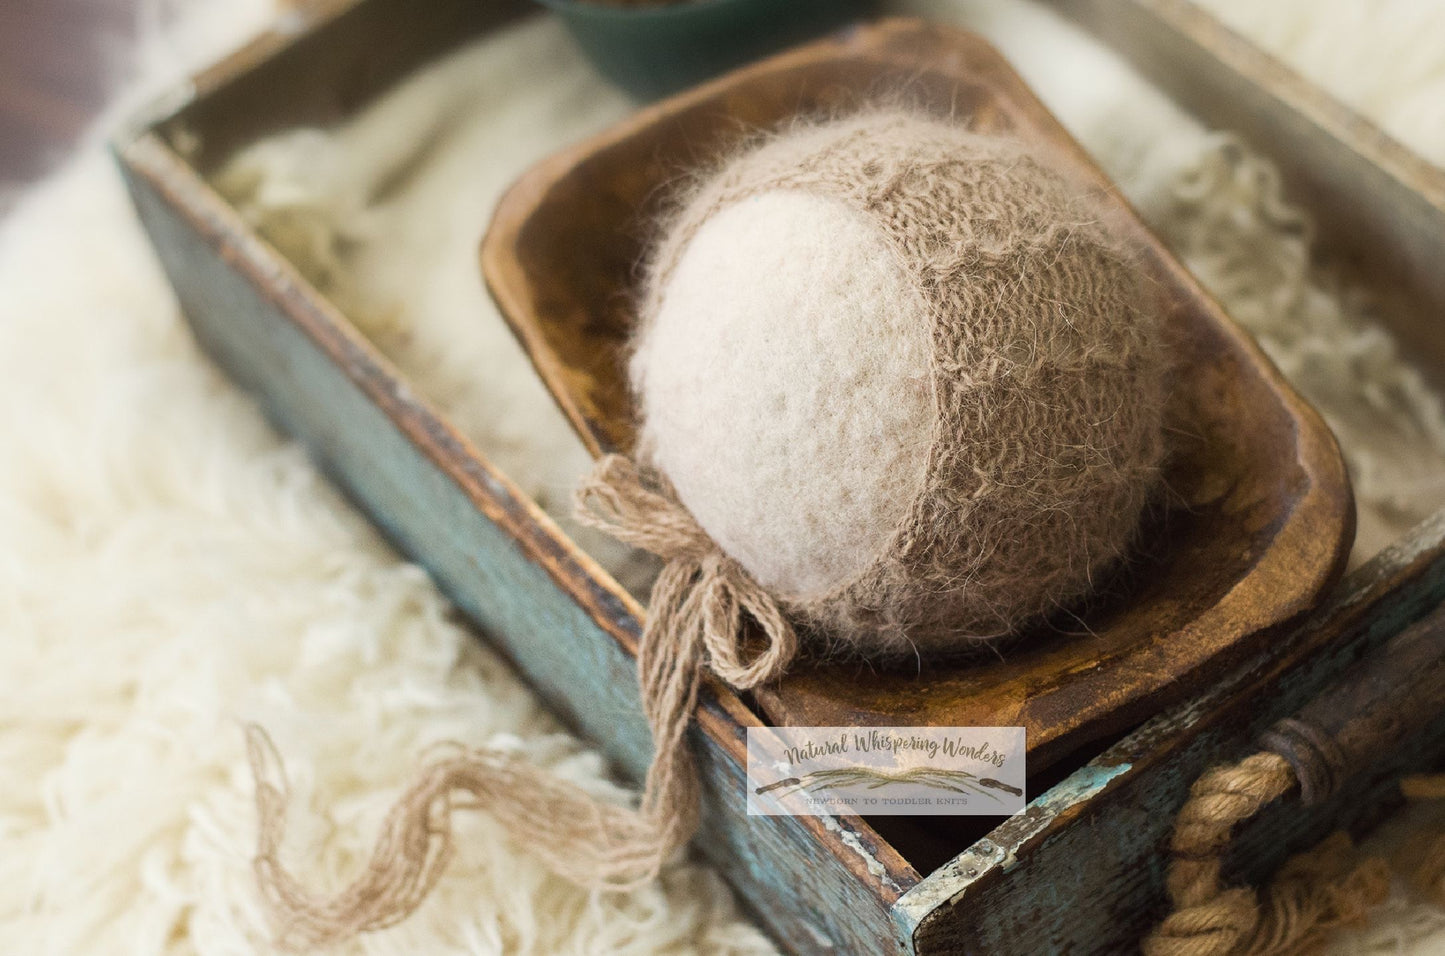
[250,113,1163,947]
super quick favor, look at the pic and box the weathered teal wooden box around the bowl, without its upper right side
[116,0,1445,955]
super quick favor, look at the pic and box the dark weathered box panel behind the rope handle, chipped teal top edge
[894,513,1445,956]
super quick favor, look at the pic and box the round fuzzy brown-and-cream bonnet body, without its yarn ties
[630,113,1163,657]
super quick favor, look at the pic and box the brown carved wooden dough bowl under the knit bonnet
[481,20,1354,771]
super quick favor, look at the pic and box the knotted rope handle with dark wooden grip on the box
[1143,607,1445,956]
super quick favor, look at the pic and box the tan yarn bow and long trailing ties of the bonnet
[247,455,798,950]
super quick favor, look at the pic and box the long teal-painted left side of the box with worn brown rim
[121,137,916,953]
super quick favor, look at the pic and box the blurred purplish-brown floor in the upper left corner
[0,0,142,197]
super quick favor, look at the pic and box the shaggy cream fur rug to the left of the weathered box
[0,0,772,956]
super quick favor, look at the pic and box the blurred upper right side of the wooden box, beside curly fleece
[1053,0,1445,392]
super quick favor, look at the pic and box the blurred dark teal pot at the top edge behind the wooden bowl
[539,0,873,100]
